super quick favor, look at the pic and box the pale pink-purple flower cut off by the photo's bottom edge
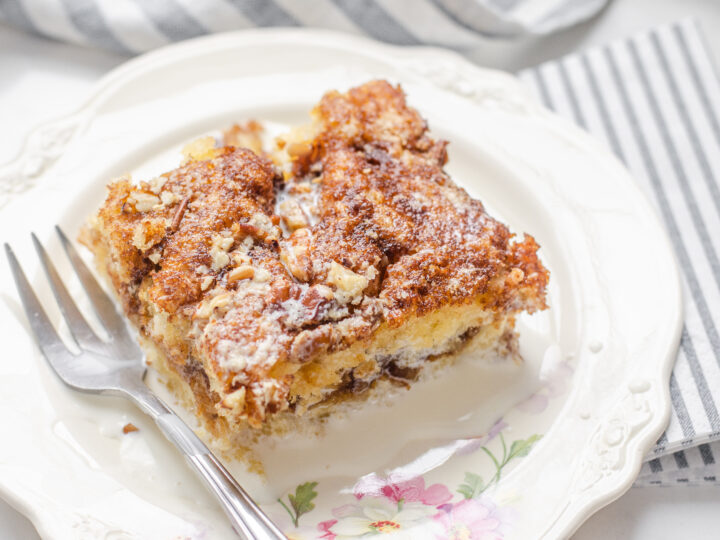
[433,498,505,540]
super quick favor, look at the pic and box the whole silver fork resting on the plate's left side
[5,226,285,540]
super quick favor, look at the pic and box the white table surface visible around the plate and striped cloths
[0,0,720,540]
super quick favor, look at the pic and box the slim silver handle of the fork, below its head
[131,390,286,540]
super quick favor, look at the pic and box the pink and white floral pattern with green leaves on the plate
[278,430,541,540]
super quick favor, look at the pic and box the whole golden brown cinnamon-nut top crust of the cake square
[83,81,548,427]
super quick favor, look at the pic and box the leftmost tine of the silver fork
[5,243,74,364]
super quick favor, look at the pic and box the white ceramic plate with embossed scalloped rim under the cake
[0,30,681,539]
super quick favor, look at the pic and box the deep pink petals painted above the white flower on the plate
[353,475,452,506]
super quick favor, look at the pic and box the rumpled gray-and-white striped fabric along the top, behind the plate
[0,0,607,55]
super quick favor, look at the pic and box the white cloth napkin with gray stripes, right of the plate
[520,20,720,485]
